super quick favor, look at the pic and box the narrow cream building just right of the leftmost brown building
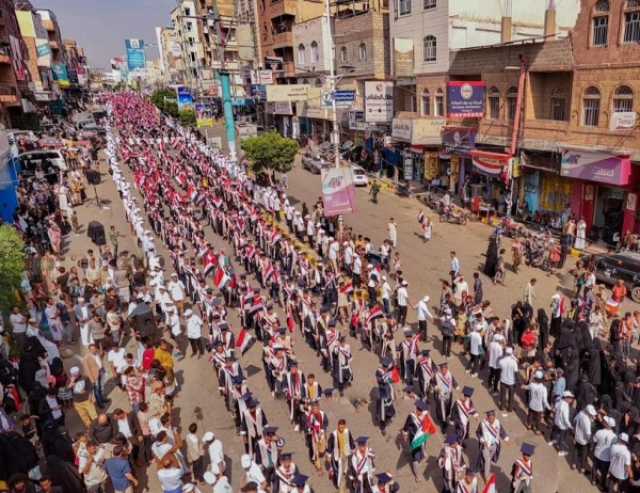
[15,0,58,105]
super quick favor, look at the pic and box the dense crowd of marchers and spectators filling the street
[0,90,640,493]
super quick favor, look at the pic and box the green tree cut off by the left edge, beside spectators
[0,225,26,310]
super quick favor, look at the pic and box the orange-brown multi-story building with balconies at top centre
[257,0,324,83]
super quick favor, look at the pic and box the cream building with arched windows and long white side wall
[390,0,580,113]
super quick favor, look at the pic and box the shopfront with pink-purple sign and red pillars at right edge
[561,149,638,243]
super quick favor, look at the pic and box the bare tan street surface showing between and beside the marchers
[57,151,624,493]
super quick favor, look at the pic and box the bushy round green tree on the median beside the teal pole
[240,132,298,174]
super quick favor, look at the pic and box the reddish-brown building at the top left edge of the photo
[0,0,30,127]
